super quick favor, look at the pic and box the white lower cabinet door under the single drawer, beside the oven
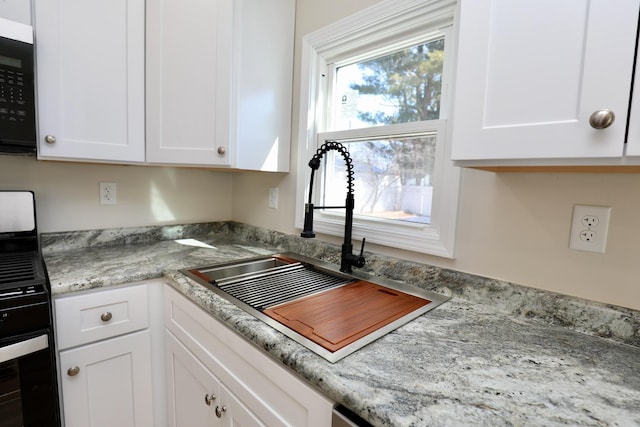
[60,330,153,427]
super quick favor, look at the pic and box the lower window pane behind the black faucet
[323,134,437,224]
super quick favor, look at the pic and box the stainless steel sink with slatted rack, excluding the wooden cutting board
[180,253,449,363]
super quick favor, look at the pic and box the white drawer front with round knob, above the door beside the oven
[54,285,149,350]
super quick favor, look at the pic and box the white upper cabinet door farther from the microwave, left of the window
[147,0,233,166]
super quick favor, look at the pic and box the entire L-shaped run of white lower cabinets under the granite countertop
[55,281,333,427]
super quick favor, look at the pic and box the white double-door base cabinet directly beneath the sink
[164,287,333,427]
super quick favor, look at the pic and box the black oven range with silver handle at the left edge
[0,191,60,427]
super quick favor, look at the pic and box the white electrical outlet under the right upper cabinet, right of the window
[569,205,611,254]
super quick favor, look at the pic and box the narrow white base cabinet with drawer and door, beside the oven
[54,282,166,427]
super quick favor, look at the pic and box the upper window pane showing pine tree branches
[331,39,444,130]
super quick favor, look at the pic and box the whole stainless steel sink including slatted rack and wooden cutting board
[181,253,448,363]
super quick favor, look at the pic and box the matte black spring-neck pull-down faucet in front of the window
[300,141,365,273]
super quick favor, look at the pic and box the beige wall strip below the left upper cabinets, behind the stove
[0,156,232,232]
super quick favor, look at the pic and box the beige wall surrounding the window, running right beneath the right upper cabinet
[233,0,640,309]
